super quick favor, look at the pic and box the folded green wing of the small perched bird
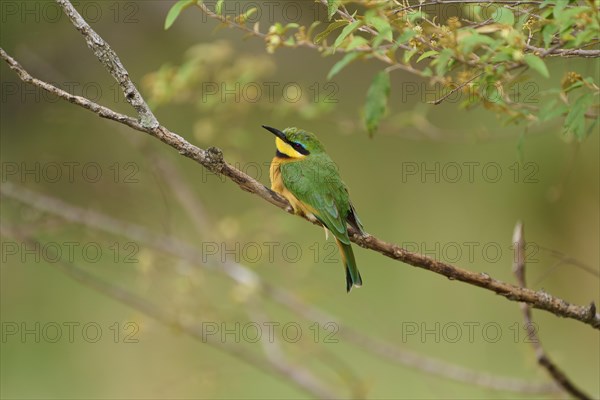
[281,155,351,244]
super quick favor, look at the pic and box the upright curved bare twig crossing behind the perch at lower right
[513,221,591,400]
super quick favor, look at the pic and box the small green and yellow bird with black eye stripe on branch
[263,125,364,292]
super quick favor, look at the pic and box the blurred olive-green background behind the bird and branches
[0,1,600,399]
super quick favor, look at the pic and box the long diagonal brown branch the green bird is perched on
[0,48,600,329]
